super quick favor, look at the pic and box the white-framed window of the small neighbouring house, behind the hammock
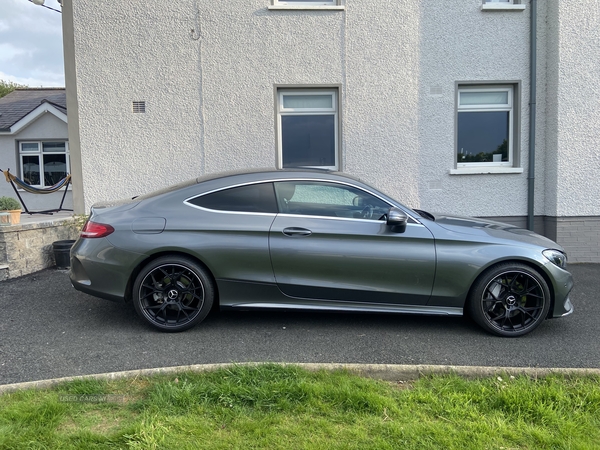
[19,141,69,187]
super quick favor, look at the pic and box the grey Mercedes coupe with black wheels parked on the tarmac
[70,170,573,337]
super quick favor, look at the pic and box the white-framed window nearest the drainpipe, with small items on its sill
[456,85,517,169]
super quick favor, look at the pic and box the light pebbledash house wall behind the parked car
[63,0,600,262]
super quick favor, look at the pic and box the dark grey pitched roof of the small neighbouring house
[0,88,67,132]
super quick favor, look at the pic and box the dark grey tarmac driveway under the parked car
[0,264,600,385]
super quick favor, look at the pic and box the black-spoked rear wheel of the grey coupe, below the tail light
[133,256,214,331]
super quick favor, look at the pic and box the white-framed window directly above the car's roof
[277,89,339,170]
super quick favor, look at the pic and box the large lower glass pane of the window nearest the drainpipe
[457,111,510,163]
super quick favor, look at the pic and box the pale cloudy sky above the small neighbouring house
[0,0,65,87]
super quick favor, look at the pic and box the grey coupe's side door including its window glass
[269,180,435,305]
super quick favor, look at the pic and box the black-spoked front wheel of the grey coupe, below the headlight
[467,263,550,337]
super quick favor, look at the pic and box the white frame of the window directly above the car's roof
[277,88,340,170]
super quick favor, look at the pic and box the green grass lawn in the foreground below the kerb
[0,364,600,450]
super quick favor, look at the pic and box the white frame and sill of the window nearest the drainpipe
[450,83,523,174]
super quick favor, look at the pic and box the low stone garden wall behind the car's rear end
[0,217,79,280]
